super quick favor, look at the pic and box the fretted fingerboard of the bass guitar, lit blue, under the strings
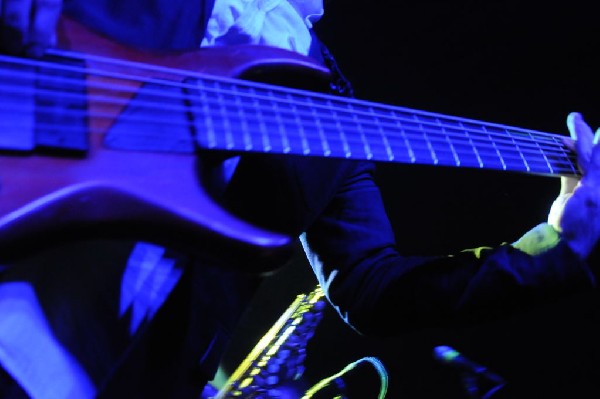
[189,77,578,175]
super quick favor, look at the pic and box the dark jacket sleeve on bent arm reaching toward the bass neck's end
[301,162,595,336]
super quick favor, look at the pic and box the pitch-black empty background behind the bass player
[218,0,600,399]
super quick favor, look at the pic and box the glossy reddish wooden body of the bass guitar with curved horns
[0,19,327,272]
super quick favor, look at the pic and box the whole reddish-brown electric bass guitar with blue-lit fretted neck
[0,18,578,268]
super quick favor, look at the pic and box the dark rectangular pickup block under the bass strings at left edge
[0,52,89,155]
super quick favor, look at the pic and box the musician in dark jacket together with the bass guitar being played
[0,0,600,398]
